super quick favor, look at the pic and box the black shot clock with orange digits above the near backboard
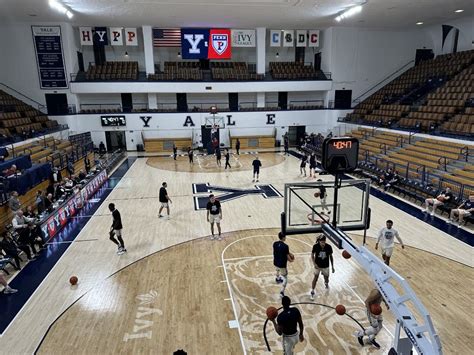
[321,137,359,174]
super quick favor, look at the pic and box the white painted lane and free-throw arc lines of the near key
[221,234,394,355]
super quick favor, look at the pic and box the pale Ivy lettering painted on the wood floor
[123,290,163,342]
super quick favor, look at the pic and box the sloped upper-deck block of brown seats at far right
[346,50,474,134]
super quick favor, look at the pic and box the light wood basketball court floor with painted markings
[0,153,474,354]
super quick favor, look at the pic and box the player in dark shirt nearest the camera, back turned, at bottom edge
[271,296,304,355]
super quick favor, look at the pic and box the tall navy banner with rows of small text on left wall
[31,26,68,90]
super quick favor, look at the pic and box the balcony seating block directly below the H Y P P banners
[85,62,138,81]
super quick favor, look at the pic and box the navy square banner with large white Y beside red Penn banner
[181,28,209,59]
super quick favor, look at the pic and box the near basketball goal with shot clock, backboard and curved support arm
[278,137,443,355]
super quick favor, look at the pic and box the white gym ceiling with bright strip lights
[0,0,474,29]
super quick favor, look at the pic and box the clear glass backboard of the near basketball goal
[282,180,370,234]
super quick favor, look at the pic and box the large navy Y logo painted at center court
[193,183,283,211]
